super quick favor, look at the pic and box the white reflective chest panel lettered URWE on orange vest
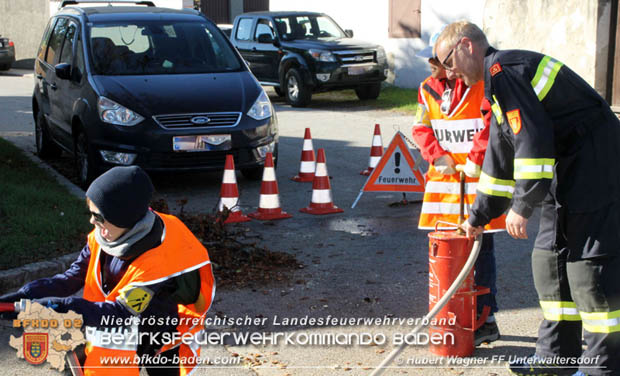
[431,117,484,153]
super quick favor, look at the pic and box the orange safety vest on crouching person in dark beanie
[84,213,215,376]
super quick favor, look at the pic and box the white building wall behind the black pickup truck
[269,0,484,88]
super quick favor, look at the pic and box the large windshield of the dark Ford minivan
[90,21,242,75]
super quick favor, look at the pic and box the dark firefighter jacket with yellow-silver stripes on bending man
[469,47,620,230]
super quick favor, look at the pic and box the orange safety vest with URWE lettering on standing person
[418,81,506,232]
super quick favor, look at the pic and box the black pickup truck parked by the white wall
[230,12,388,107]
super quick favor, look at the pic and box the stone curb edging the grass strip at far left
[0,132,85,294]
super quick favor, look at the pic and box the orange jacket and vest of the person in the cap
[413,77,505,231]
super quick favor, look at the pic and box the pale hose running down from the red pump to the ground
[370,235,482,376]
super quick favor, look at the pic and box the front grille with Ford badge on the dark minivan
[153,112,241,129]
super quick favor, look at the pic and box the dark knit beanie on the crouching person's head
[86,166,153,228]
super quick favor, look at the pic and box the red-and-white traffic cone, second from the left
[248,153,292,221]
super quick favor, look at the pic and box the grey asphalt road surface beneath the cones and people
[0,72,542,376]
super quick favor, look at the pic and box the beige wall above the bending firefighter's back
[483,0,611,96]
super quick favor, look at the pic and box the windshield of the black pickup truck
[275,16,346,40]
